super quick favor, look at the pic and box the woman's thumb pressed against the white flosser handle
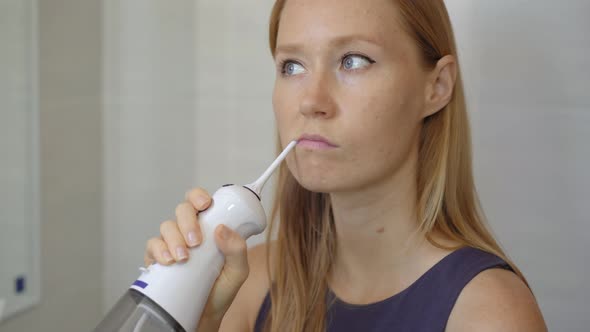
[215,224,249,285]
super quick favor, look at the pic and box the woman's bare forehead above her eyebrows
[277,0,403,47]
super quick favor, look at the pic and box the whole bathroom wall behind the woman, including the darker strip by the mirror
[0,0,590,332]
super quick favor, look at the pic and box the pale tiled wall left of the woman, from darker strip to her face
[103,0,275,311]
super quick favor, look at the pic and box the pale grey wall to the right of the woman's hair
[446,0,590,331]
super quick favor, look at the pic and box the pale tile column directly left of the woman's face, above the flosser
[195,0,276,213]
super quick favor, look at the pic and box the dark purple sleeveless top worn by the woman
[254,247,512,332]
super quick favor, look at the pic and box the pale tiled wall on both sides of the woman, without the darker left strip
[104,0,590,331]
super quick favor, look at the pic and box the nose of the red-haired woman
[299,73,336,118]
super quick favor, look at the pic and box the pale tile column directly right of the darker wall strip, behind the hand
[103,0,196,310]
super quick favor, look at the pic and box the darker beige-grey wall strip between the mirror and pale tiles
[0,0,103,332]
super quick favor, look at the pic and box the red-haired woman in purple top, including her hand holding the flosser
[145,0,546,331]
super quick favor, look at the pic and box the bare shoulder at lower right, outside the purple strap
[446,268,547,332]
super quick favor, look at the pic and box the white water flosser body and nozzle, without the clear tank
[131,141,297,331]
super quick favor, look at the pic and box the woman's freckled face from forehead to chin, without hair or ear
[273,0,428,192]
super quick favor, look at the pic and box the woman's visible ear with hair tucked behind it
[423,55,457,118]
